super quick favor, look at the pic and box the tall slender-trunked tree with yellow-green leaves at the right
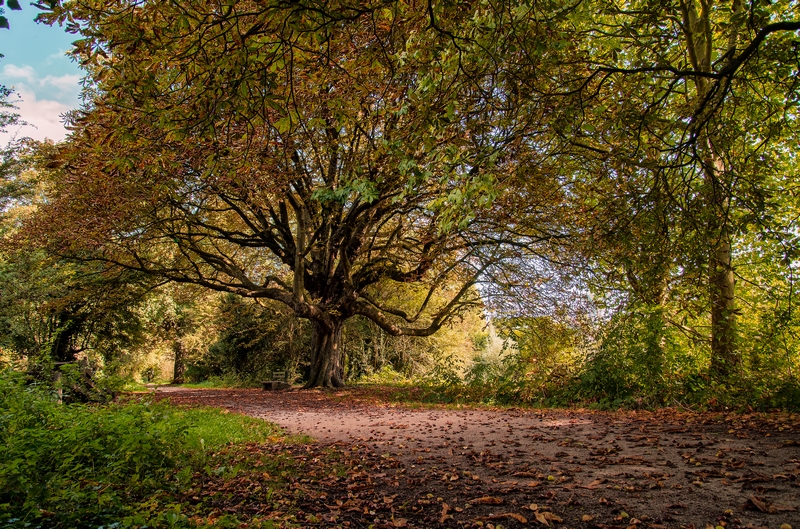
[500,0,800,377]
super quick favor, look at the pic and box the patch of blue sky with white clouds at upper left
[0,7,81,145]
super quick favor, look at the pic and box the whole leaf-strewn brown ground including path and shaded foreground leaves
[157,387,800,529]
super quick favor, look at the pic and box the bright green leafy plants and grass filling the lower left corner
[0,372,277,528]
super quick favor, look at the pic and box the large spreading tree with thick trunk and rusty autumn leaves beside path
[27,0,552,386]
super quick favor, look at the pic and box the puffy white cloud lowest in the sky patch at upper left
[0,88,71,145]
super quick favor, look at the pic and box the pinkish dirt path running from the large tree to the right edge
[153,387,800,529]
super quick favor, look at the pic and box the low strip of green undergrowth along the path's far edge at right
[359,359,800,411]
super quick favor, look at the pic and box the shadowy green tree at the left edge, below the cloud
[0,140,159,366]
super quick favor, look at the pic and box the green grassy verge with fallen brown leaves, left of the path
[0,373,306,529]
